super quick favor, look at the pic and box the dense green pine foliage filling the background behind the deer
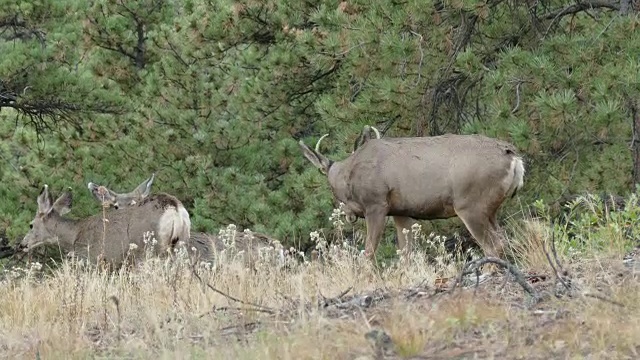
[0,0,640,253]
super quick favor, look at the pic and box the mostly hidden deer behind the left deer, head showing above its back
[87,174,282,263]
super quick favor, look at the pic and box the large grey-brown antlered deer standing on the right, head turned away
[299,129,525,259]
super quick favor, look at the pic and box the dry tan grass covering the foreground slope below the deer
[0,218,640,359]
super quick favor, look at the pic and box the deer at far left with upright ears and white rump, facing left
[19,185,191,268]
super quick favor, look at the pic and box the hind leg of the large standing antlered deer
[457,209,504,258]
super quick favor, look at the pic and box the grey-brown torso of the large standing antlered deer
[328,135,516,218]
